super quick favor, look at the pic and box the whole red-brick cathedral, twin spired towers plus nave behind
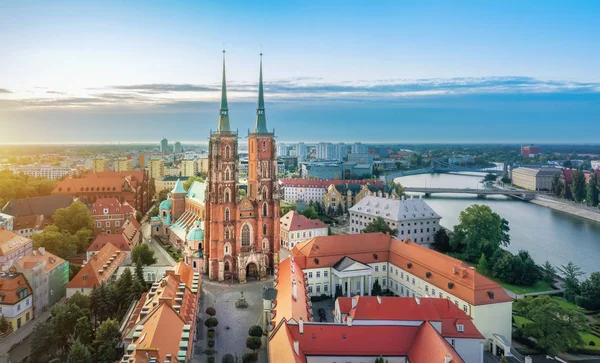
[152,52,280,282]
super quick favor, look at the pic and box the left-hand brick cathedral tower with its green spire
[204,51,238,281]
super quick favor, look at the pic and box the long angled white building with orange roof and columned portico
[291,233,513,351]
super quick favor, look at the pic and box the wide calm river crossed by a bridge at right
[395,174,600,275]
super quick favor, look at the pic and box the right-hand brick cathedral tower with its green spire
[248,53,280,271]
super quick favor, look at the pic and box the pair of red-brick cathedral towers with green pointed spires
[203,51,280,282]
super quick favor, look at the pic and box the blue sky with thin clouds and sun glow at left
[0,0,600,143]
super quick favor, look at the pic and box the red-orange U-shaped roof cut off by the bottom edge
[269,320,464,363]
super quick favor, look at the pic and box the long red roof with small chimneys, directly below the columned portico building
[337,296,483,339]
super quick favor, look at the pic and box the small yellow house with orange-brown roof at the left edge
[0,268,33,331]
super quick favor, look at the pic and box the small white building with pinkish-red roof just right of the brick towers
[280,210,329,250]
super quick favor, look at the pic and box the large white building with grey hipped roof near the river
[348,195,442,247]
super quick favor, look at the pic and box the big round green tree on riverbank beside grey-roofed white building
[450,204,510,261]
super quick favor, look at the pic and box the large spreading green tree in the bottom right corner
[515,295,587,354]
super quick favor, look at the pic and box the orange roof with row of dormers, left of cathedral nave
[67,243,125,289]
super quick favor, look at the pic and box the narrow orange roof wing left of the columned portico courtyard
[273,258,310,322]
